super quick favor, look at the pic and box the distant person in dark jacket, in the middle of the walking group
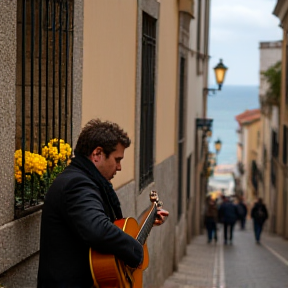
[218,196,238,245]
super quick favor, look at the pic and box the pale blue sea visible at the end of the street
[207,85,260,165]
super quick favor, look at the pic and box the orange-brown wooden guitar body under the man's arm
[89,217,149,288]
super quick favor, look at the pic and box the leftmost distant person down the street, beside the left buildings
[205,196,218,243]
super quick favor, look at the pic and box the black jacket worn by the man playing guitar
[38,155,143,288]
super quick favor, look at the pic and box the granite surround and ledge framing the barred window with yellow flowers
[0,0,83,288]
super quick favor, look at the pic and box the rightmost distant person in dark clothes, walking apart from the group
[251,198,268,244]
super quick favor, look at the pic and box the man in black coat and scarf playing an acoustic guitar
[38,119,169,288]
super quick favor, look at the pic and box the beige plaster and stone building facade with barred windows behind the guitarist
[0,0,210,287]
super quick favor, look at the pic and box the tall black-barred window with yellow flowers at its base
[15,0,74,217]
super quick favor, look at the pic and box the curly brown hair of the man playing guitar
[75,119,131,157]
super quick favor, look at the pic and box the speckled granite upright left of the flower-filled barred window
[0,0,17,226]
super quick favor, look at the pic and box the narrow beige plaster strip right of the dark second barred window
[155,0,178,164]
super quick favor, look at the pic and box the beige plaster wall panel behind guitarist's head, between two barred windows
[82,0,137,188]
